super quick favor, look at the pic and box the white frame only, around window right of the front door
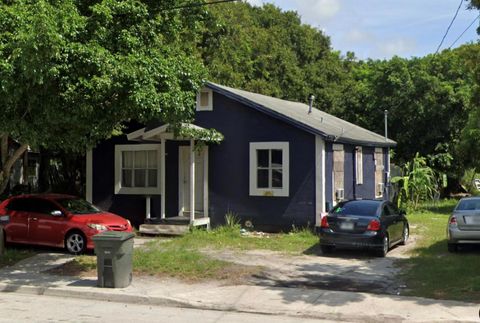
[250,141,290,196]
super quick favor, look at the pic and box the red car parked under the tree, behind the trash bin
[0,194,132,254]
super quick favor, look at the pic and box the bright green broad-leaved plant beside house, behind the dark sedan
[392,153,438,209]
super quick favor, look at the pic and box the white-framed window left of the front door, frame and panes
[115,144,161,194]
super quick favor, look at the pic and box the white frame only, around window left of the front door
[114,144,162,195]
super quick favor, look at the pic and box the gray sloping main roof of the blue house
[206,82,396,147]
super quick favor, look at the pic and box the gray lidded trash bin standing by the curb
[92,231,135,288]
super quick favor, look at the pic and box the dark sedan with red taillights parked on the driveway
[317,200,409,257]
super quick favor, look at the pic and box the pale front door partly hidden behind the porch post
[178,146,208,216]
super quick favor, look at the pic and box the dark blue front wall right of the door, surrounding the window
[195,92,315,231]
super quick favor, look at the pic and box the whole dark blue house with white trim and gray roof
[87,83,395,233]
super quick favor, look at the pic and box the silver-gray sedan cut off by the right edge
[447,197,480,252]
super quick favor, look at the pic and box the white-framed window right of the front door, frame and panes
[250,142,289,196]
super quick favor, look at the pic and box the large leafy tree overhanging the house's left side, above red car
[0,0,204,192]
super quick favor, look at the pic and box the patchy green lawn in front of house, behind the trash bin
[60,227,318,281]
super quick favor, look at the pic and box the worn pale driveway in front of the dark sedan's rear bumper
[202,236,416,295]
